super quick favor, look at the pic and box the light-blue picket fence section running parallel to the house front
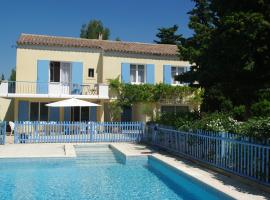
[14,122,144,143]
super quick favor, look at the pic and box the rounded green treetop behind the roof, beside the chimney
[80,20,110,40]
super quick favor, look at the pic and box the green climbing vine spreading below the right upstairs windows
[108,77,204,109]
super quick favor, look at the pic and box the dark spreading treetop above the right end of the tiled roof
[154,25,182,44]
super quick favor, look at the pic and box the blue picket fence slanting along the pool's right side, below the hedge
[143,125,270,185]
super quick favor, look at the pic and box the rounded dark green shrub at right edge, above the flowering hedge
[251,99,270,117]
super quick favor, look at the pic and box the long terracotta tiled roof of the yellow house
[17,34,178,56]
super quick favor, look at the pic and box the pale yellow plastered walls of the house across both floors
[10,46,190,121]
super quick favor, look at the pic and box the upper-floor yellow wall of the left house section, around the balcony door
[16,46,102,84]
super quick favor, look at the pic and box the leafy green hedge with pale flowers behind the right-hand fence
[155,112,270,139]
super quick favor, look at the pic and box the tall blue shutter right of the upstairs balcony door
[71,62,83,94]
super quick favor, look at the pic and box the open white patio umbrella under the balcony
[46,98,100,107]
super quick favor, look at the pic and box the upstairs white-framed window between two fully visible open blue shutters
[130,64,146,84]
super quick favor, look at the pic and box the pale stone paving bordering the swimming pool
[0,143,270,200]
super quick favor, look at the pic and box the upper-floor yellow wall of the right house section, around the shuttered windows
[103,52,190,83]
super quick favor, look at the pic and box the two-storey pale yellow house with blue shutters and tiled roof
[0,34,190,121]
